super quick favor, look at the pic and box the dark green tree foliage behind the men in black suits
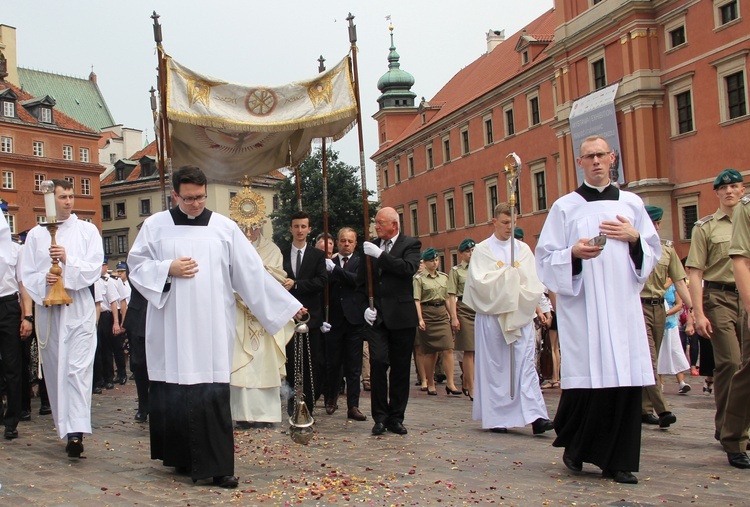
[271,148,378,250]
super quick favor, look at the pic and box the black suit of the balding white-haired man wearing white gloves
[357,234,422,426]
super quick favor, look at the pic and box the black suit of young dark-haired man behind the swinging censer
[282,245,328,415]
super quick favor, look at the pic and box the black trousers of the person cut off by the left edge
[0,296,22,428]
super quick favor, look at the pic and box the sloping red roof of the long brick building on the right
[373,9,556,156]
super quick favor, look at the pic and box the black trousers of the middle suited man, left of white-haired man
[323,319,364,408]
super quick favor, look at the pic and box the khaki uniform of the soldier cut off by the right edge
[721,196,750,460]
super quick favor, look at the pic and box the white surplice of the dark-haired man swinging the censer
[128,211,302,385]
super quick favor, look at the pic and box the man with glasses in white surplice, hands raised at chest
[536,136,661,484]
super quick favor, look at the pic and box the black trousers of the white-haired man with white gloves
[364,323,416,424]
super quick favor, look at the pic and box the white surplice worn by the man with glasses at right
[536,191,661,389]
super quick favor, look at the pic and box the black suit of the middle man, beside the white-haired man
[325,254,365,408]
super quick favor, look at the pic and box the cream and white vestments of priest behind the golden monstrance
[230,236,294,423]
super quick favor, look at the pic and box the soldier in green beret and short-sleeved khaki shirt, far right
[685,169,747,456]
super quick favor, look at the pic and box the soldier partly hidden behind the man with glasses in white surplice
[641,206,693,429]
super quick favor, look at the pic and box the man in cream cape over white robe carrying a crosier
[463,203,552,435]
